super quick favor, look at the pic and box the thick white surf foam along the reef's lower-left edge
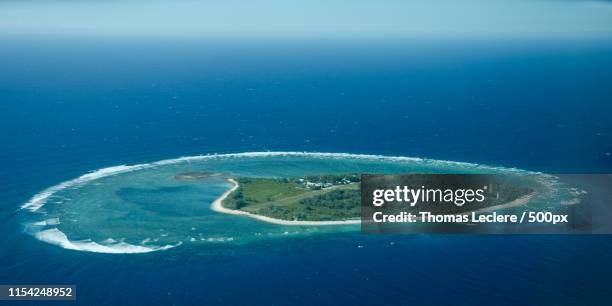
[34,228,181,254]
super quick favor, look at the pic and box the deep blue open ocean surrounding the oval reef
[0,36,612,305]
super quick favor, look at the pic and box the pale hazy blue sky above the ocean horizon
[0,0,612,37]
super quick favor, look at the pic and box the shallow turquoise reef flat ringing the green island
[20,152,575,253]
